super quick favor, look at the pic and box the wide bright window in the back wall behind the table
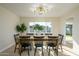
[29,22,52,33]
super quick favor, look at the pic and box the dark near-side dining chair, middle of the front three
[34,36,44,56]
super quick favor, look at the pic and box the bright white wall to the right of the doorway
[73,12,79,55]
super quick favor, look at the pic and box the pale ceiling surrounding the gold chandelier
[0,3,79,17]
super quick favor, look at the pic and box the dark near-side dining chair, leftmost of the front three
[19,36,31,56]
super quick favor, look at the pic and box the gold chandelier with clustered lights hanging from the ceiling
[34,5,48,15]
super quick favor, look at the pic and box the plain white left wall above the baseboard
[0,7,19,52]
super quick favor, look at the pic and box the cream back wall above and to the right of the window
[20,17,60,35]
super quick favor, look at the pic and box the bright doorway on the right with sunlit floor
[65,23,73,48]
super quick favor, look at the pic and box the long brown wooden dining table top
[20,36,58,41]
